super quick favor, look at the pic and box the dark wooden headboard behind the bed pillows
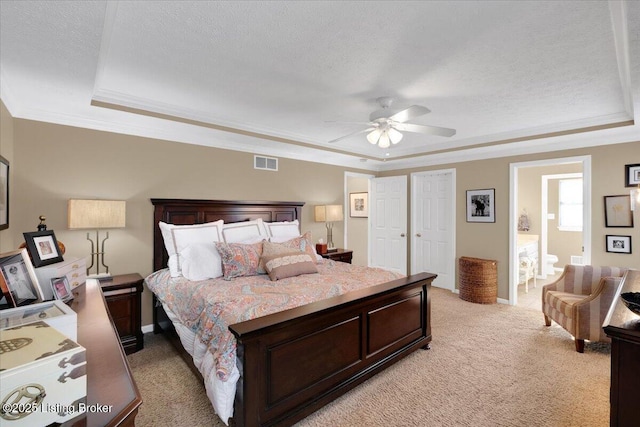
[151,199,304,271]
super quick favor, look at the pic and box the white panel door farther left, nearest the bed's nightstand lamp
[369,176,407,274]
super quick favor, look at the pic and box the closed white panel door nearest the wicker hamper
[411,171,455,290]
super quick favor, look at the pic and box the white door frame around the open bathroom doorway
[509,155,591,305]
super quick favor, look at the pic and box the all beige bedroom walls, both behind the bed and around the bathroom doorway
[0,103,640,324]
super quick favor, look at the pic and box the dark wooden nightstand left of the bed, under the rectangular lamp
[100,273,144,354]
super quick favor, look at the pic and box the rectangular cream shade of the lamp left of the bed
[67,199,126,230]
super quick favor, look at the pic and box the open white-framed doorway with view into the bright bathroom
[509,156,591,305]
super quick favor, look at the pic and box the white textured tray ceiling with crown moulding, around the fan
[0,0,640,170]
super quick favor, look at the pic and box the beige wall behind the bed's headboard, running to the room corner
[10,119,368,324]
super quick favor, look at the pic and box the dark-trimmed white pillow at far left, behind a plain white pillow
[158,220,224,277]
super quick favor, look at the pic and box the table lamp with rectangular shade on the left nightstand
[67,199,126,276]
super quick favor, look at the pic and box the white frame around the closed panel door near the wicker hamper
[409,168,457,292]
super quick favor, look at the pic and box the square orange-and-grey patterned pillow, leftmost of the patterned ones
[216,242,265,280]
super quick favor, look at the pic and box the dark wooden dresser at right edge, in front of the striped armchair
[604,270,640,427]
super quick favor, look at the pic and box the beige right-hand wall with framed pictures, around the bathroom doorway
[380,141,640,299]
